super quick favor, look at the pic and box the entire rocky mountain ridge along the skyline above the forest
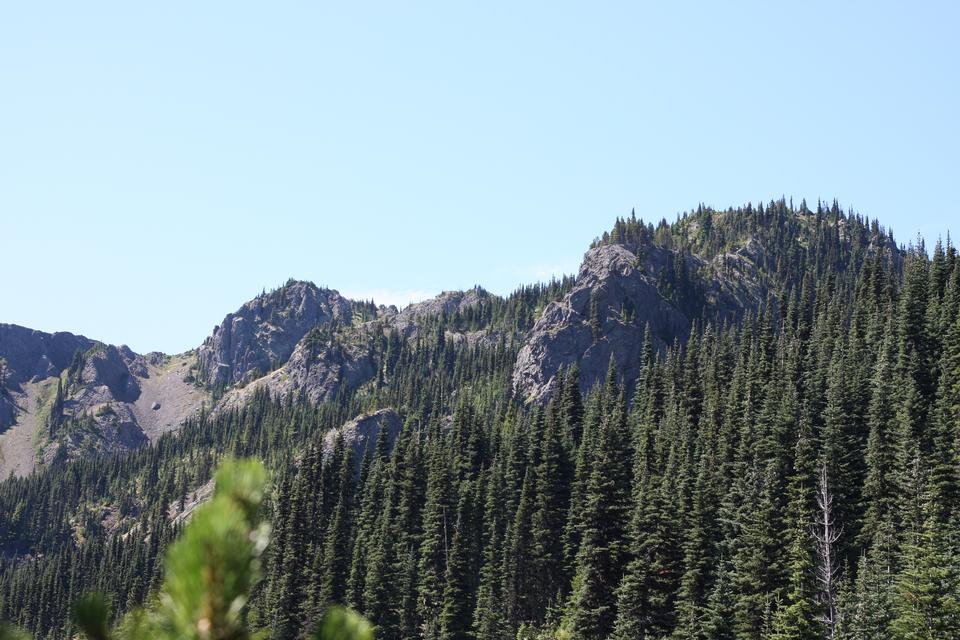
[0,200,900,480]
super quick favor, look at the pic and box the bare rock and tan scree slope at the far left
[0,324,209,474]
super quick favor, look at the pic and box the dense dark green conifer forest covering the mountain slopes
[0,201,960,640]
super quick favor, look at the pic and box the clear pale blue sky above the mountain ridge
[0,1,960,352]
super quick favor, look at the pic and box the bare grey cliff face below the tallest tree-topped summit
[513,238,764,402]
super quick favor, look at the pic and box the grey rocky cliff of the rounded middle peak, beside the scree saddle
[197,281,351,388]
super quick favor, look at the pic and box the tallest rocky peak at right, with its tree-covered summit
[513,200,902,402]
